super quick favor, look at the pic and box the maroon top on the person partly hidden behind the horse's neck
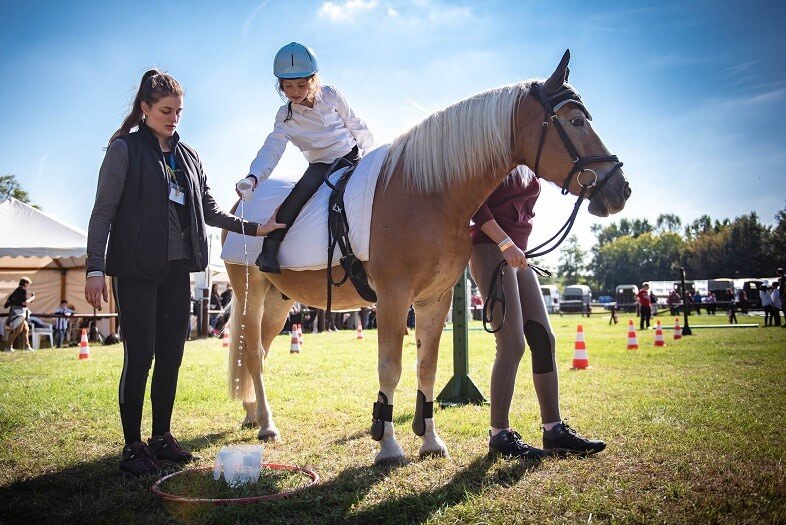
[472,177,540,250]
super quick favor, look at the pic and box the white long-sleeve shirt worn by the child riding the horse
[249,86,374,181]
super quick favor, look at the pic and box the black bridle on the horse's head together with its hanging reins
[483,83,622,334]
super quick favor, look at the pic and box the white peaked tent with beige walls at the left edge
[0,198,115,322]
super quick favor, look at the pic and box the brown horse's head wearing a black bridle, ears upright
[522,50,631,217]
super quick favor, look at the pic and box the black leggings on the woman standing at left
[112,259,191,444]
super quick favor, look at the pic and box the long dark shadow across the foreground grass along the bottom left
[0,436,537,523]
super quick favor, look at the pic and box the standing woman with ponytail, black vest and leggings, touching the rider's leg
[85,70,284,476]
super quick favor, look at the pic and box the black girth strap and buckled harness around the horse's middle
[325,157,377,314]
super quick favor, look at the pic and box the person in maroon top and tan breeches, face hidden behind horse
[470,166,606,458]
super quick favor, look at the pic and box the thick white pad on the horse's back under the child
[221,145,389,270]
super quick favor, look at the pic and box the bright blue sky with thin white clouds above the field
[0,0,786,264]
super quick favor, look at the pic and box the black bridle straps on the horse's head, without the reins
[530,82,622,199]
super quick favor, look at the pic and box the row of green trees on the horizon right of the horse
[557,207,786,295]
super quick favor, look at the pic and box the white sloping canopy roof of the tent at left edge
[0,197,87,269]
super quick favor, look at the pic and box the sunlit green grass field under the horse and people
[0,316,786,524]
